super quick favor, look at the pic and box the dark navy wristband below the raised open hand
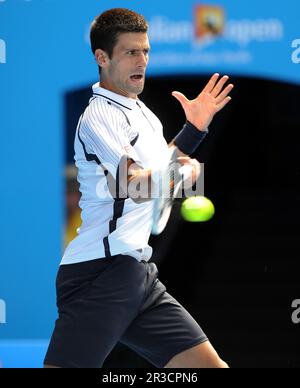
[173,121,208,155]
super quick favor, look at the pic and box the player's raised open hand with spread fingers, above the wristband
[172,73,233,131]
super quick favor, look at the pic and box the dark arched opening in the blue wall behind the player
[66,75,300,368]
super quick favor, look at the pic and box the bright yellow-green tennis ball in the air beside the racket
[181,196,215,222]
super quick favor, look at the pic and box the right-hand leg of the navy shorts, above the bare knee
[121,263,207,368]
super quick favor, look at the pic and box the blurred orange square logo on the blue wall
[195,5,224,40]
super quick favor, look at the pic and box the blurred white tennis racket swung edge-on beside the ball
[151,147,182,235]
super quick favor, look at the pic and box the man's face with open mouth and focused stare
[101,32,150,98]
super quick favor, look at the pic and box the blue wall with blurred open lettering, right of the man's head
[148,0,300,83]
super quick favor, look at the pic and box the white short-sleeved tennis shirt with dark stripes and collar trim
[61,83,168,264]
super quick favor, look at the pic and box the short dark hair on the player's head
[90,8,148,58]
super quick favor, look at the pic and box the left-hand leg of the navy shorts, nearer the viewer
[45,255,145,368]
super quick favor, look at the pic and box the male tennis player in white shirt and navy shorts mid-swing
[44,8,233,368]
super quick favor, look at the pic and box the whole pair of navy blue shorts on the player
[44,255,207,368]
